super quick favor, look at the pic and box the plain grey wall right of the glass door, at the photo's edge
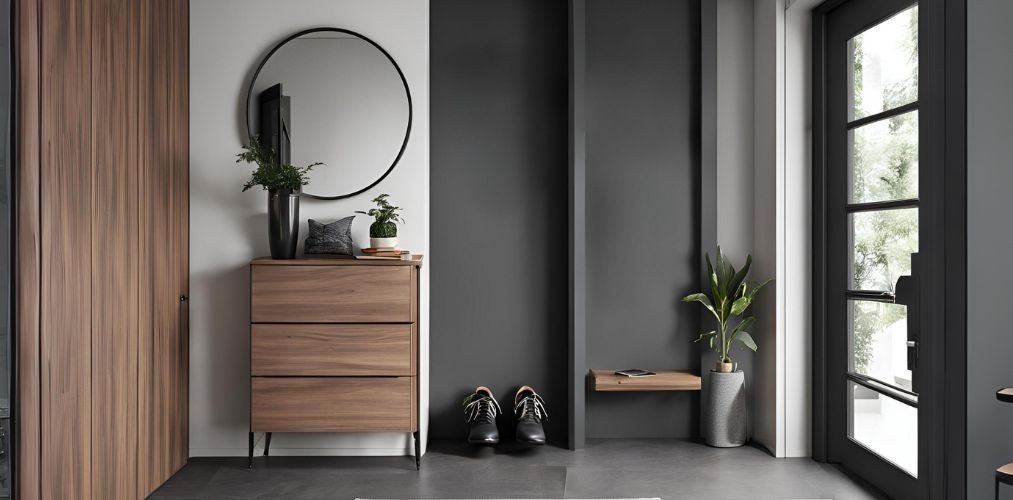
[967,0,1013,499]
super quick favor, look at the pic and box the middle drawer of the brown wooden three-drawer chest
[250,324,414,377]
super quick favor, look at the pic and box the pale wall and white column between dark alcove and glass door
[703,0,816,456]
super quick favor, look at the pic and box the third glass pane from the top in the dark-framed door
[848,209,918,291]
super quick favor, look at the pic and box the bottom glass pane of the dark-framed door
[848,382,918,478]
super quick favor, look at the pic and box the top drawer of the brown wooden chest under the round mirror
[250,265,414,323]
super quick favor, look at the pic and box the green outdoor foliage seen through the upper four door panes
[850,7,919,373]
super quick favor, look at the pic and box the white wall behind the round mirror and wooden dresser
[189,0,430,456]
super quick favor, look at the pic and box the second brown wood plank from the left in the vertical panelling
[41,0,92,500]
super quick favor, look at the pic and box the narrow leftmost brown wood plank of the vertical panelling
[14,0,42,500]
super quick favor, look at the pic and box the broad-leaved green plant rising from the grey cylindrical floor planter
[683,247,770,372]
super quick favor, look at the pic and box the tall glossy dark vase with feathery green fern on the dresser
[236,136,323,259]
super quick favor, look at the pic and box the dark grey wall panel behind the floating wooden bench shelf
[587,0,700,437]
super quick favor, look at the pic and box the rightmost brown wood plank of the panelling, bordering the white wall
[139,0,189,496]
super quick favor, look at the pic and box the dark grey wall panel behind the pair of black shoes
[430,0,568,442]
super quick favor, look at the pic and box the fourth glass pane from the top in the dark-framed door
[848,301,912,391]
